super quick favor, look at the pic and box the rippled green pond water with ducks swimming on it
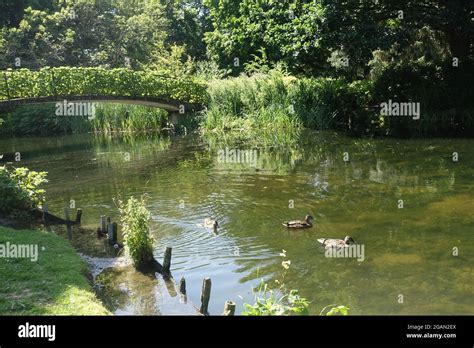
[0,131,474,315]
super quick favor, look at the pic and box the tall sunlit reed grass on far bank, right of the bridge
[202,70,376,136]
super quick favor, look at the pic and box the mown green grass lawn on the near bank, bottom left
[0,227,110,315]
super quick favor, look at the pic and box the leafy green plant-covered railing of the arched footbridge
[0,67,207,104]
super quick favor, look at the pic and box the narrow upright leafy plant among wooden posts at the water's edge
[118,197,153,268]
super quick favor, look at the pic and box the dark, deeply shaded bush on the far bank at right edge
[372,61,474,137]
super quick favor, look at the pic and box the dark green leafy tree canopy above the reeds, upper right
[205,0,474,77]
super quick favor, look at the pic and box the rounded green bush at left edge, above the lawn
[0,166,48,217]
